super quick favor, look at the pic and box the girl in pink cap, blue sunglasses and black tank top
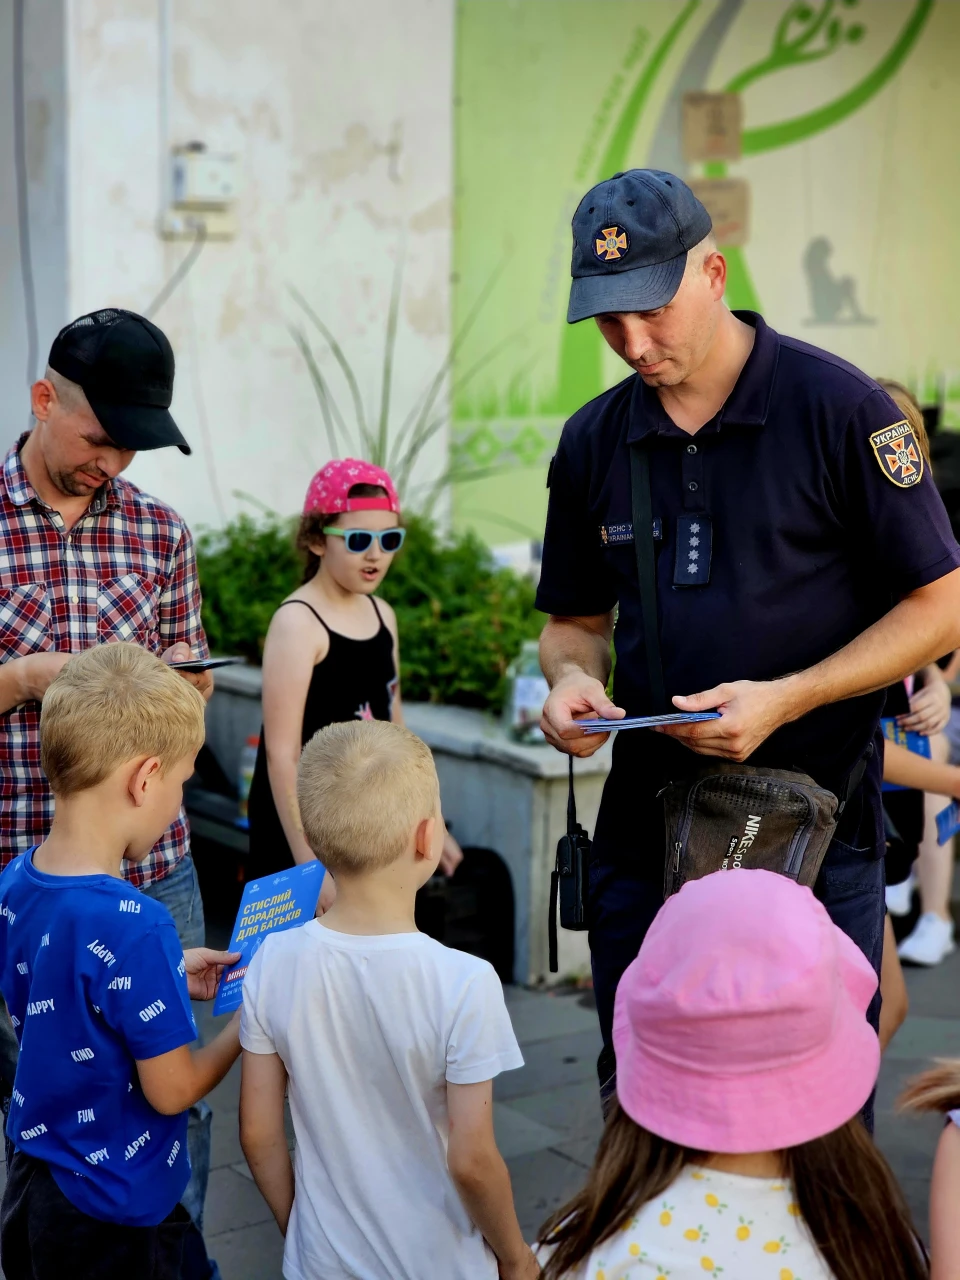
[248,458,462,910]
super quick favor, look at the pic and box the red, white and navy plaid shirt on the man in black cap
[0,435,207,886]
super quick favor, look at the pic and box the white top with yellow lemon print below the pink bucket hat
[541,1165,833,1280]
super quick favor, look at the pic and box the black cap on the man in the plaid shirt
[47,307,191,453]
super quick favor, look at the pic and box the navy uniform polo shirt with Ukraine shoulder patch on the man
[536,311,960,829]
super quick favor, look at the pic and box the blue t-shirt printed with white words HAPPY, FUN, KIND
[0,849,197,1226]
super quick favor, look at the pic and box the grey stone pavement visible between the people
[0,931,960,1280]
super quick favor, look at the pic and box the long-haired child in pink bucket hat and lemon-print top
[539,870,929,1280]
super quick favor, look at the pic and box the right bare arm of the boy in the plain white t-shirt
[447,1080,540,1280]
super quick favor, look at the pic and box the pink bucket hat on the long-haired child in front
[613,870,879,1153]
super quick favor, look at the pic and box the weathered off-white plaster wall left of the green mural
[65,0,453,525]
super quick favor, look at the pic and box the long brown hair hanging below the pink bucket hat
[539,1103,929,1280]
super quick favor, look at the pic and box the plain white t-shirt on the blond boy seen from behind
[241,920,527,1280]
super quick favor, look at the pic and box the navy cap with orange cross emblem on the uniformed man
[567,169,713,324]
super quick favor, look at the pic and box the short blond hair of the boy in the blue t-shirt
[40,644,205,796]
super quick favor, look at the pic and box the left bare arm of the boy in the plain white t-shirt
[241,1050,293,1235]
